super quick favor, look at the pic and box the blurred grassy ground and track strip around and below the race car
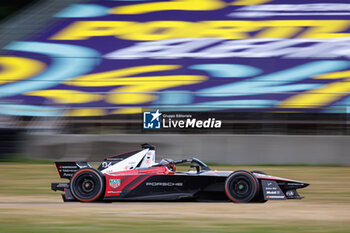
[0,163,350,233]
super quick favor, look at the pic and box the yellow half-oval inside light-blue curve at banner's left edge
[0,57,46,84]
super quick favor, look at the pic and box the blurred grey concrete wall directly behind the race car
[23,134,350,165]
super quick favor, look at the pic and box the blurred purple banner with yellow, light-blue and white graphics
[0,0,350,116]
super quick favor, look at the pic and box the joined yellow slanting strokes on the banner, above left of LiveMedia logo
[66,65,207,104]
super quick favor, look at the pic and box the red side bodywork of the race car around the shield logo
[105,166,174,197]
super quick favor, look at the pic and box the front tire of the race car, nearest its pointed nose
[225,171,259,203]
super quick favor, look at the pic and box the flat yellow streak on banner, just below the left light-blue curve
[26,90,104,104]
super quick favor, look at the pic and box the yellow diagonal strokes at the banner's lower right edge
[278,70,350,108]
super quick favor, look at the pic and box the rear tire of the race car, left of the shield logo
[70,168,106,202]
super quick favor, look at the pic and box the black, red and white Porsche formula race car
[51,144,309,202]
